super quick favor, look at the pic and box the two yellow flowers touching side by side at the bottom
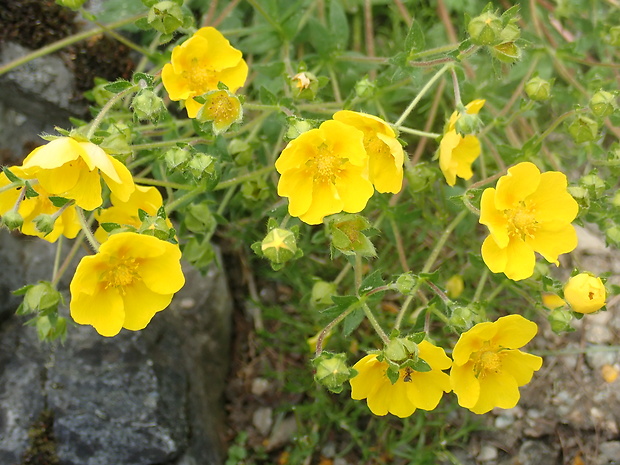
[350,315,542,417]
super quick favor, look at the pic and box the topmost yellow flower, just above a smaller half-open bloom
[161,27,248,118]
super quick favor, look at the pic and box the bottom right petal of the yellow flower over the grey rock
[123,281,173,331]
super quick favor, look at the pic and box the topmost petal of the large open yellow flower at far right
[495,162,540,210]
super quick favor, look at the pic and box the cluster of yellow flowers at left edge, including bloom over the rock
[0,136,184,336]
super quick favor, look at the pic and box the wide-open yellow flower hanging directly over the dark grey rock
[70,232,185,337]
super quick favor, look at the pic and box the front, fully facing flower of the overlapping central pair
[276,120,374,224]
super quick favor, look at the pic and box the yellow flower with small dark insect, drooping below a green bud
[350,341,451,418]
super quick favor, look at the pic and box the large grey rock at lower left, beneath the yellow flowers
[0,231,231,465]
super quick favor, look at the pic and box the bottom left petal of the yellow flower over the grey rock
[70,288,125,337]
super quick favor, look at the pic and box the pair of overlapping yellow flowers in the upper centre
[275,110,405,224]
